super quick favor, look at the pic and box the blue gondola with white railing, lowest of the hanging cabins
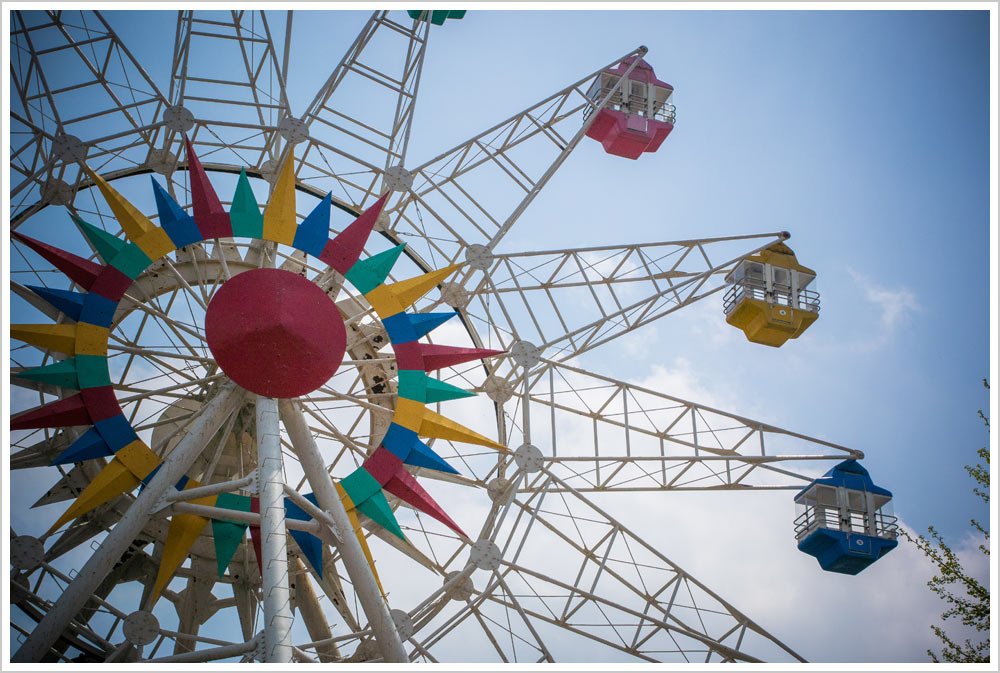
[795,459,898,575]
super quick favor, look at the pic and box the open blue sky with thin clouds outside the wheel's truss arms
[5,9,996,660]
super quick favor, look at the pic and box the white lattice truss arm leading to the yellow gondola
[414,233,783,368]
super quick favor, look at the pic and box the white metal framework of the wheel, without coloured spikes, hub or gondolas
[7,11,861,662]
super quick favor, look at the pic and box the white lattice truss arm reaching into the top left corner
[10,11,167,215]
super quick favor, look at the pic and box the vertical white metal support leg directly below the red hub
[256,395,292,664]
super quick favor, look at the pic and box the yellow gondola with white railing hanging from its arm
[723,243,819,347]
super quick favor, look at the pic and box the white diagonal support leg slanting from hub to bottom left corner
[11,383,245,662]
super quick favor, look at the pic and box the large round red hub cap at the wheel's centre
[205,269,347,398]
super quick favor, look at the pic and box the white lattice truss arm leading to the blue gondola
[505,361,863,492]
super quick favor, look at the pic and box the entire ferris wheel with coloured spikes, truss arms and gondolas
[8,10,895,663]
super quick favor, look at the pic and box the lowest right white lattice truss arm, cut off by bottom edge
[396,468,802,662]
